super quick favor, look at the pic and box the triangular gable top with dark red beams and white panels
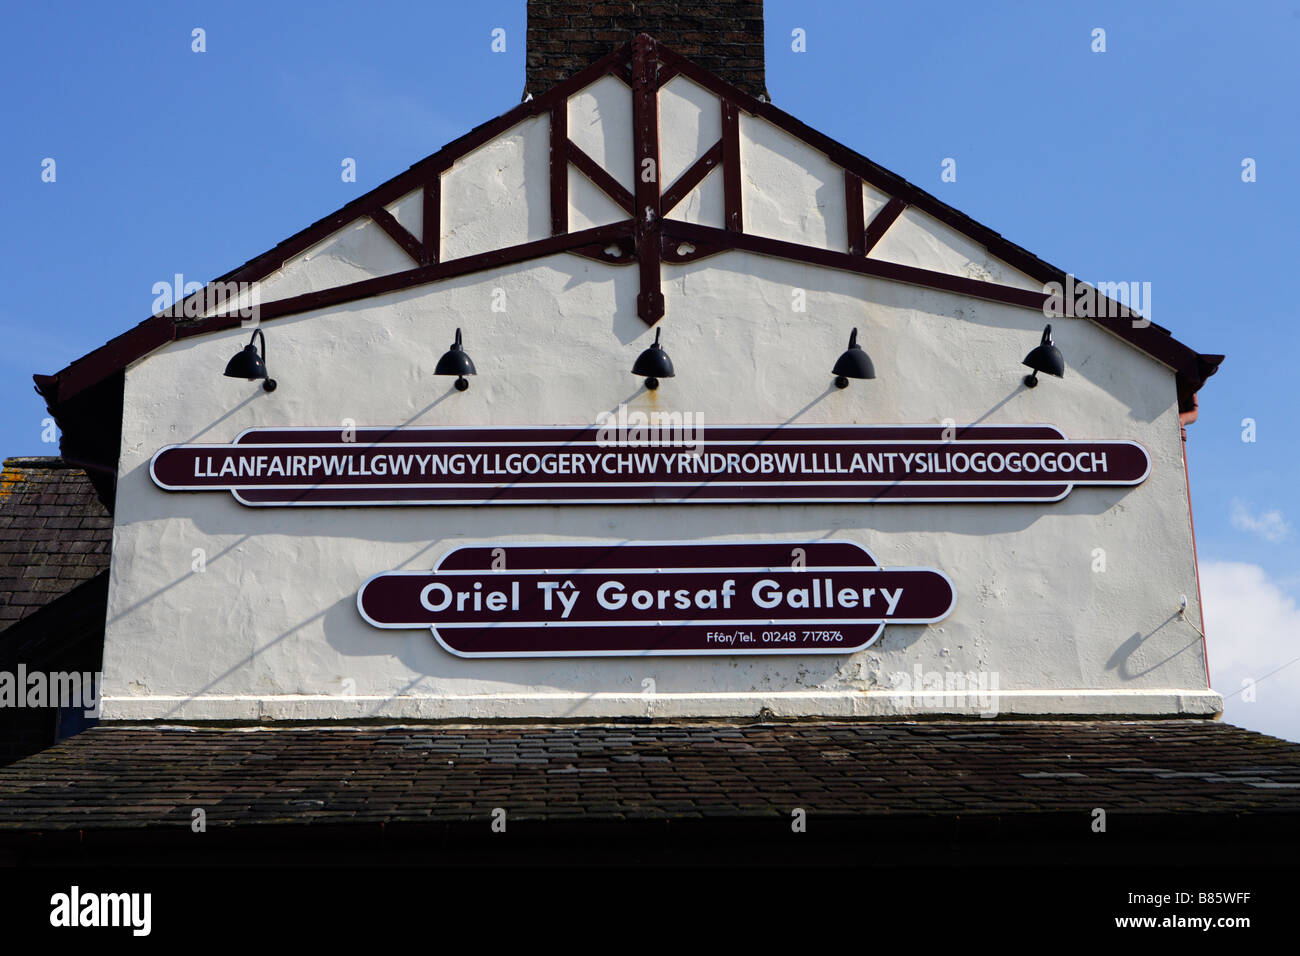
[35,36,1222,426]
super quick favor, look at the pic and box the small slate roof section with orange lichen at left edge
[0,458,113,632]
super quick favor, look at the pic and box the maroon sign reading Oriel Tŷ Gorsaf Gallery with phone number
[356,541,954,657]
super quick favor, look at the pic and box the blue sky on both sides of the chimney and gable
[0,0,1300,737]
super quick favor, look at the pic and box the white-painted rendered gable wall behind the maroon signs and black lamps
[104,88,1221,719]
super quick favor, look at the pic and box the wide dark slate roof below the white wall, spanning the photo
[0,719,1300,843]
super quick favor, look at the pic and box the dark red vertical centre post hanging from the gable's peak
[632,34,663,325]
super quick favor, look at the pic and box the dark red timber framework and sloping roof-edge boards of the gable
[34,35,1223,429]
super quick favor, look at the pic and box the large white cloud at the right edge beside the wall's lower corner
[1201,561,1300,740]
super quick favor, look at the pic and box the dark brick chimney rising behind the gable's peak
[524,0,767,100]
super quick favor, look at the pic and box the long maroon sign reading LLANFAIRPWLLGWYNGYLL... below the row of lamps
[150,425,1151,506]
